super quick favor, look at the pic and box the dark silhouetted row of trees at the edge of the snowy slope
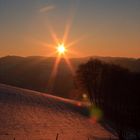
[76,59,140,139]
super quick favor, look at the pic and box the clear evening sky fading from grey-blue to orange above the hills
[0,0,140,58]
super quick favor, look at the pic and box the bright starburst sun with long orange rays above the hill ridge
[35,9,83,91]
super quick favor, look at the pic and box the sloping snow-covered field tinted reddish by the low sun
[0,84,115,140]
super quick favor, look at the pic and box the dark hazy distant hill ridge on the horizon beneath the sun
[0,56,140,98]
